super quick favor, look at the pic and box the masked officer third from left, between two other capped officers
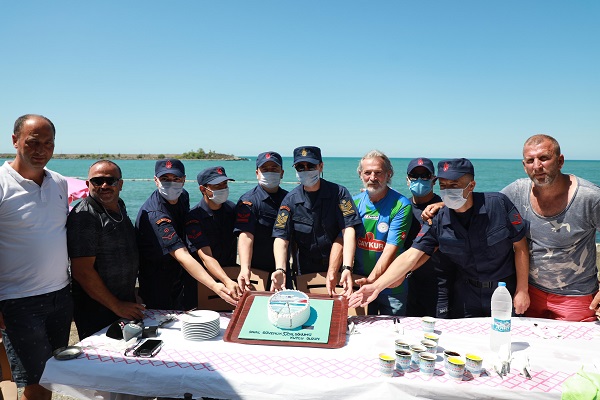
[235,151,288,290]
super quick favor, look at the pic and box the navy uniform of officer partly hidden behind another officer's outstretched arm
[404,194,455,318]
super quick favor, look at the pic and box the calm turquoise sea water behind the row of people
[0,156,600,227]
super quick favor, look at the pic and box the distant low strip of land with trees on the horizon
[0,149,249,161]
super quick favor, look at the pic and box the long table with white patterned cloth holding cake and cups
[41,310,600,400]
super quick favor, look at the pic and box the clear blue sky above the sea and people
[0,0,600,160]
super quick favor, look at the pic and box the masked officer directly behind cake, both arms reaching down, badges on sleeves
[271,146,362,293]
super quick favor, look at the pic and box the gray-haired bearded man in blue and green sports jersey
[342,150,412,315]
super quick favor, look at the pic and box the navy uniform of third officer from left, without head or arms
[234,185,288,272]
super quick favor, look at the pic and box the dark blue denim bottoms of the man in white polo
[0,285,73,387]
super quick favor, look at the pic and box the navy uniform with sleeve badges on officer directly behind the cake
[273,179,362,274]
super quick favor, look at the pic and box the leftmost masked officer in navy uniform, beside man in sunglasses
[135,158,237,310]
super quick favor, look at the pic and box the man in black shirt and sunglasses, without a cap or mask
[67,160,144,339]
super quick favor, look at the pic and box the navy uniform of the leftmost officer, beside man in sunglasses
[135,190,190,310]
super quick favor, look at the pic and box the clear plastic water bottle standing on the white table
[490,282,512,353]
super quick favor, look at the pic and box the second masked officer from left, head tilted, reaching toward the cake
[184,166,242,308]
